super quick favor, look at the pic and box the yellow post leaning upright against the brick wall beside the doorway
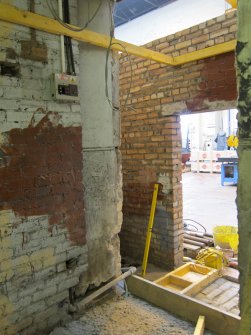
[142,184,159,277]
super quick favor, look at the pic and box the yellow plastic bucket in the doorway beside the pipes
[213,226,239,253]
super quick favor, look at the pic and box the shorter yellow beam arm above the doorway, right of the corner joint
[174,40,236,65]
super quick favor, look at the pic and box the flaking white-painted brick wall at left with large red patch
[0,1,87,335]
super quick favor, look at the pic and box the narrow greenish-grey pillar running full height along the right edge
[236,0,251,335]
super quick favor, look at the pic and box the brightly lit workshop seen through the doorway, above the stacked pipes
[181,109,238,233]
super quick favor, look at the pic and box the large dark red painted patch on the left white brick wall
[0,113,85,245]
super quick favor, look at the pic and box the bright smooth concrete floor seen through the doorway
[182,172,238,233]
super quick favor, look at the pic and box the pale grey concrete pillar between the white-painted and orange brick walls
[78,0,122,293]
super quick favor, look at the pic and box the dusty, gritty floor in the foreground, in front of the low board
[50,295,212,335]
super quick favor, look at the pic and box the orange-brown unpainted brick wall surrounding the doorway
[120,11,237,268]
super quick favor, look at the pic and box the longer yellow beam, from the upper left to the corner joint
[0,3,173,65]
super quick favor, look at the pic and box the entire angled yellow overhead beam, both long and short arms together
[0,3,236,66]
